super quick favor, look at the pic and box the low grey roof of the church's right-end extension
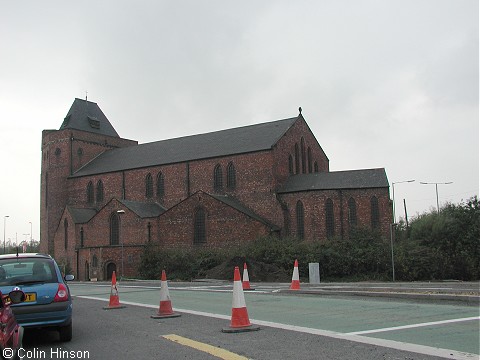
[278,168,389,193]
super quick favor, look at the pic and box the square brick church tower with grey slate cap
[40,99,137,256]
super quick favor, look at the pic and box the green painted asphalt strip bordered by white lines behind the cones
[70,284,480,354]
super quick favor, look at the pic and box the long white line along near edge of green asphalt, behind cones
[76,295,478,360]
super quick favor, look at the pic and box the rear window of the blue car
[0,258,57,286]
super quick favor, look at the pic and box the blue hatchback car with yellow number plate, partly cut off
[0,254,74,341]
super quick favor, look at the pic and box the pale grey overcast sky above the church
[0,0,479,242]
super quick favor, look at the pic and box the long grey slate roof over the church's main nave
[72,117,299,177]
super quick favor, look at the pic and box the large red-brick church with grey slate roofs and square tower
[40,99,392,280]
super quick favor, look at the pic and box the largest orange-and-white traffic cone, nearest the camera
[222,266,260,333]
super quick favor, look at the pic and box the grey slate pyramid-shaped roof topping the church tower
[60,99,119,137]
